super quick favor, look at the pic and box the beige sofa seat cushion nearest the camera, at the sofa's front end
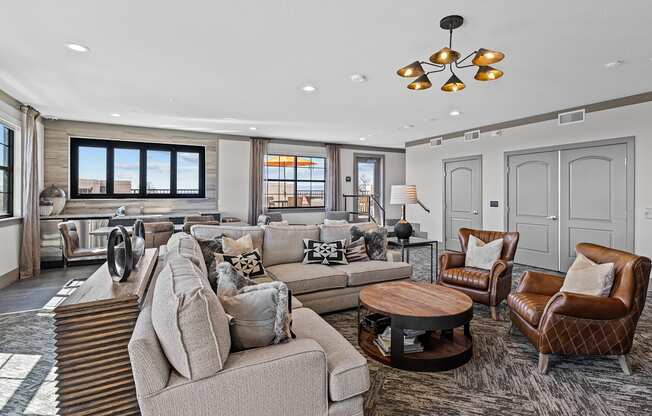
[292,308,369,402]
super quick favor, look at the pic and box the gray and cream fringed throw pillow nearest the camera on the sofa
[220,282,291,351]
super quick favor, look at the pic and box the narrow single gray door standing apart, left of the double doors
[444,158,482,251]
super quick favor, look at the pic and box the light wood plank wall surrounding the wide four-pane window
[43,120,220,214]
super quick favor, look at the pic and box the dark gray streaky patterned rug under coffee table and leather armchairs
[0,250,652,416]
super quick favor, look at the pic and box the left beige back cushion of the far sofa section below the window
[263,225,319,266]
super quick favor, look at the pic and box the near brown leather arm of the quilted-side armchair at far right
[541,292,627,322]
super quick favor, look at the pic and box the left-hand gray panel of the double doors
[507,151,559,270]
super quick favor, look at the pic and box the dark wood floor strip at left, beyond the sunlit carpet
[0,264,100,314]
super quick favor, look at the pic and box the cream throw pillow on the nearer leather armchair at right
[560,253,614,296]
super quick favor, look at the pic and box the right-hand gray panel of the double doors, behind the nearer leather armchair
[560,144,633,271]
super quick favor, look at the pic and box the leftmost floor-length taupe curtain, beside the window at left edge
[20,106,41,279]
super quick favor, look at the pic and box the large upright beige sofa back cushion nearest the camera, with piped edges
[152,257,231,380]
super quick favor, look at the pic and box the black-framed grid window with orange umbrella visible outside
[265,155,326,209]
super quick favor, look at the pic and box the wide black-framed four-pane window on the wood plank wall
[70,137,206,199]
